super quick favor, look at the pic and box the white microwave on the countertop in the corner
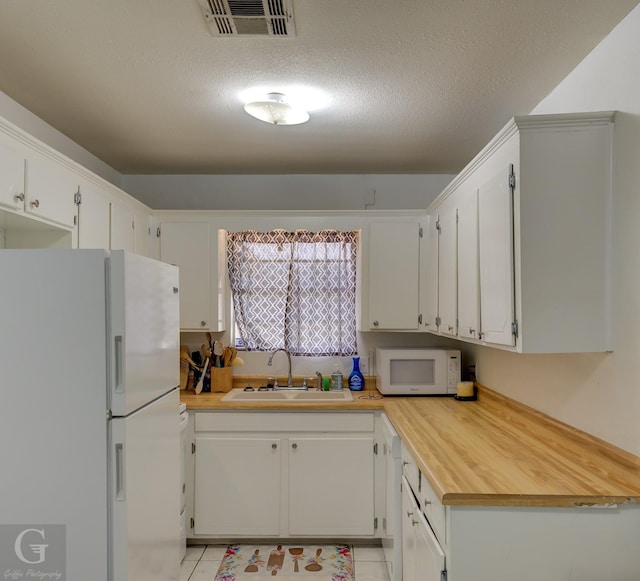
[376,347,461,395]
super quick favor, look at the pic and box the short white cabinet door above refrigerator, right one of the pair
[25,152,80,229]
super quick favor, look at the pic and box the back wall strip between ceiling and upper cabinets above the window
[122,174,454,210]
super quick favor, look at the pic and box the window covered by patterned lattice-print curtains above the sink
[227,230,359,357]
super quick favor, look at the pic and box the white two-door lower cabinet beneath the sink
[193,411,376,538]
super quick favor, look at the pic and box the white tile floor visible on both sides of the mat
[180,545,389,581]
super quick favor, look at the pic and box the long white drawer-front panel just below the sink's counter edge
[195,411,375,432]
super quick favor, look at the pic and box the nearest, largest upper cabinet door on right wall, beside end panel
[478,164,514,345]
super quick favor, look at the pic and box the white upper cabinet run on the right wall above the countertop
[428,112,613,353]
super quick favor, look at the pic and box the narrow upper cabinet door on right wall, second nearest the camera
[458,187,480,339]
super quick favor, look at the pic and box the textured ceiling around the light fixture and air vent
[0,0,638,174]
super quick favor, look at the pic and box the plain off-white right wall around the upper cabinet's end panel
[472,6,640,455]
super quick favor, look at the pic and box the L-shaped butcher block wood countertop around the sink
[181,378,640,507]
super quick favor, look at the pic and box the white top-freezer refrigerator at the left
[0,250,180,581]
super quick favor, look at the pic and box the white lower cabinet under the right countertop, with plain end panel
[402,445,640,581]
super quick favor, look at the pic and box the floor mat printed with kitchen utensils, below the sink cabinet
[214,545,355,581]
